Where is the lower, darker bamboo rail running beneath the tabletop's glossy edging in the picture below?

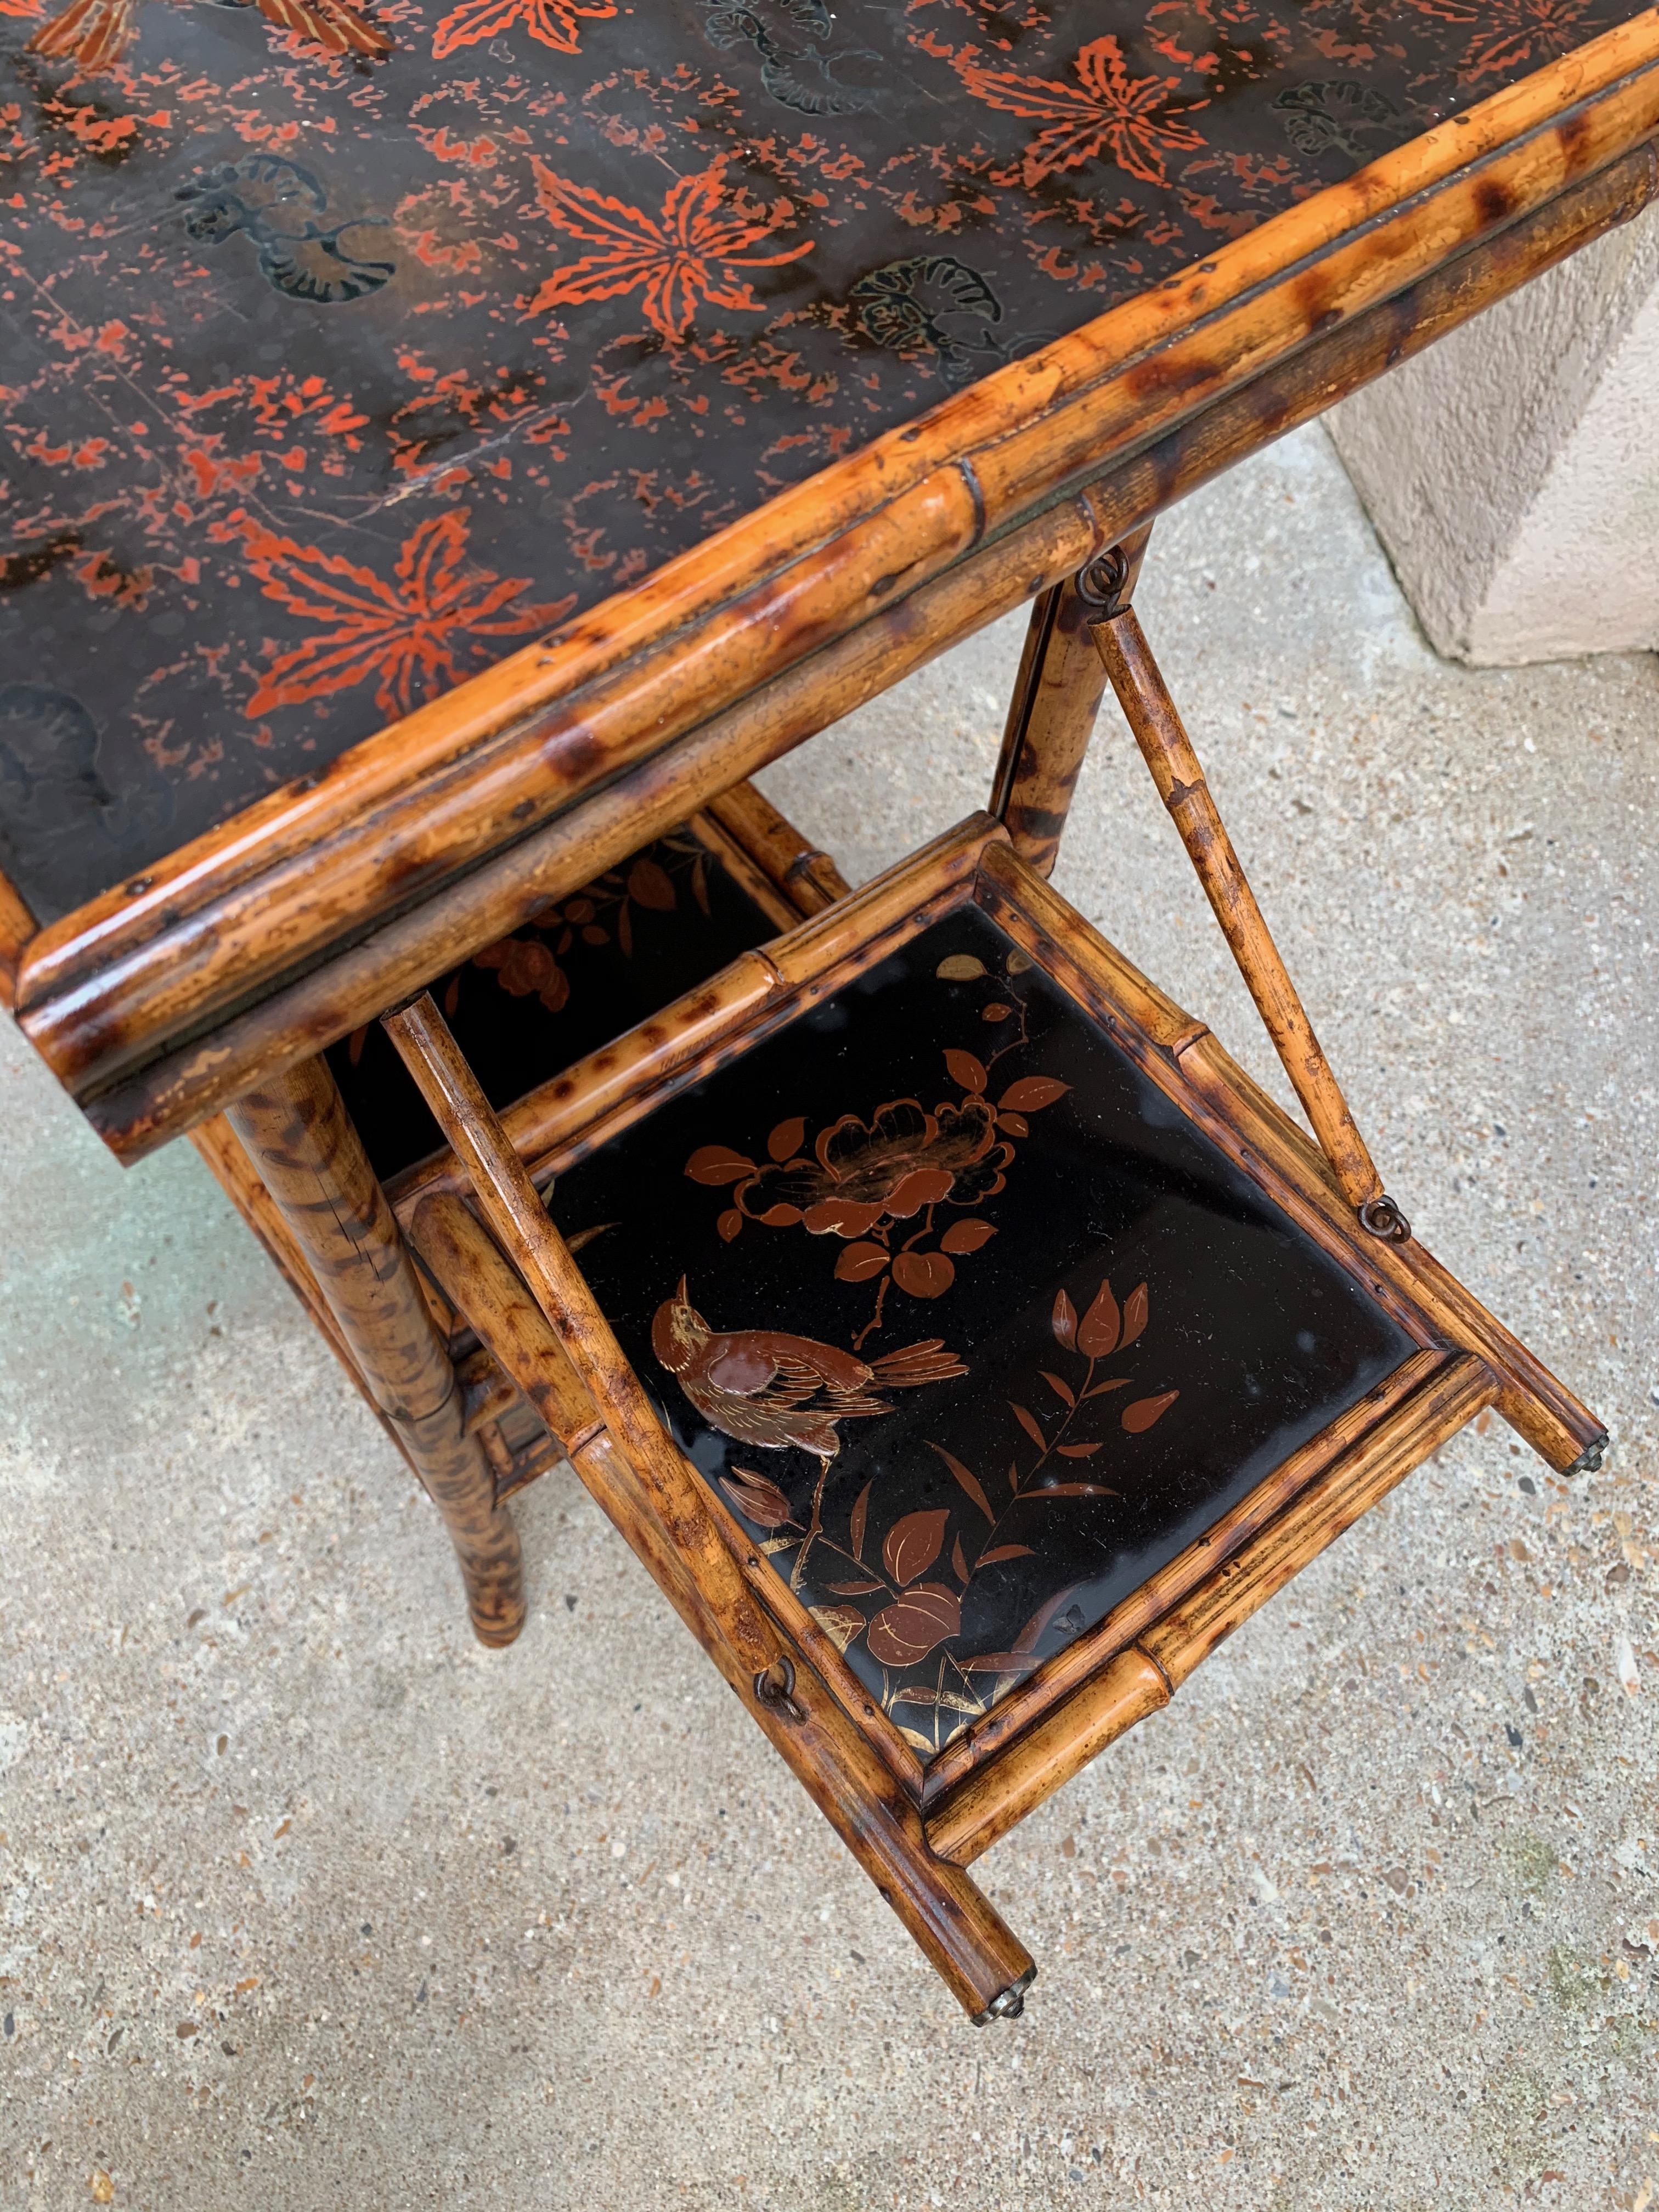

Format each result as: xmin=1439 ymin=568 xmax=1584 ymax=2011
xmin=65 ymin=129 xmax=1659 ymax=1159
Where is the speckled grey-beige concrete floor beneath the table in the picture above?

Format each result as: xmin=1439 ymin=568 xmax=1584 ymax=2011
xmin=0 ymin=431 xmax=1659 ymax=2212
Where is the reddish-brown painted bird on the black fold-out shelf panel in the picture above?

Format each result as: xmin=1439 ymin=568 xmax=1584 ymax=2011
xmin=650 ymin=1276 xmax=967 ymax=1464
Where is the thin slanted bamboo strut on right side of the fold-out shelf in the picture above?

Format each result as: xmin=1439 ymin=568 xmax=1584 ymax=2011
xmin=1091 ymin=597 xmax=1411 ymax=1243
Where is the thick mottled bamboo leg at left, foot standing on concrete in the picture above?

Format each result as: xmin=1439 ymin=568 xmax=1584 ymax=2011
xmin=228 ymin=1059 xmax=524 ymax=1646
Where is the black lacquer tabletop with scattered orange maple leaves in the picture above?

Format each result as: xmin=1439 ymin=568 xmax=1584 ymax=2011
xmin=0 ymin=0 xmax=1633 ymax=920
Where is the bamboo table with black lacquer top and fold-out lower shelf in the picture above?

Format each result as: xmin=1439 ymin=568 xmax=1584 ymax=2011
xmin=0 ymin=0 xmax=1659 ymax=2019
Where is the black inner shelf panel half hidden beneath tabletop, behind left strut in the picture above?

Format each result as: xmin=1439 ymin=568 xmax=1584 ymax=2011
xmin=336 ymin=830 xmax=778 ymax=1179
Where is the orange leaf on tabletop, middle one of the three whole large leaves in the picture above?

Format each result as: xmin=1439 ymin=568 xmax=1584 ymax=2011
xmin=529 ymin=157 xmax=812 ymax=338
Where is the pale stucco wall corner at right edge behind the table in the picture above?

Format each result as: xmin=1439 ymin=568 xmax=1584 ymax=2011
xmin=1327 ymin=208 xmax=1659 ymax=666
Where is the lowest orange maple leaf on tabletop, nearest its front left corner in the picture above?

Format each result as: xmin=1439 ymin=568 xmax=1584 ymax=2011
xmin=230 ymin=506 xmax=575 ymax=714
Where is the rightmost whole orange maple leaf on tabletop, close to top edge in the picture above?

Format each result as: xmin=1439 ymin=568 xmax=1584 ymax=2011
xmin=956 ymin=36 xmax=1207 ymax=186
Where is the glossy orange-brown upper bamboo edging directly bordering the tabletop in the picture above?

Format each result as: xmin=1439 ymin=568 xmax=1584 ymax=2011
xmin=20 ymin=30 xmax=1659 ymax=1141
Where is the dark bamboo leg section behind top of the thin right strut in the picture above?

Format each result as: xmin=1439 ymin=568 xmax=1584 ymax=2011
xmin=991 ymin=522 xmax=1153 ymax=876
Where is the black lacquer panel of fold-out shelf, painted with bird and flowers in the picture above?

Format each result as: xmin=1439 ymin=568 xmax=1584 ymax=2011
xmin=551 ymin=909 xmax=1415 ymax=1758
